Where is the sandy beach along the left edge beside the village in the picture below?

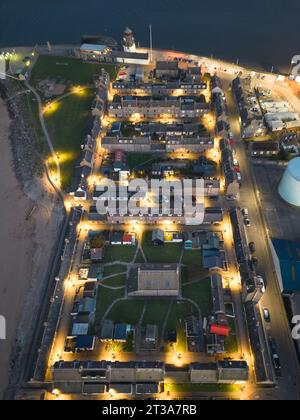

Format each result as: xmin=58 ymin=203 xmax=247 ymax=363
xmin=0 ymin=99 xmax=61 ymax=399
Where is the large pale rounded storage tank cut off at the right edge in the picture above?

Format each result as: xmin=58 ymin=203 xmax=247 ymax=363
xmin=278 ymin=157 xmax=300 ymax=207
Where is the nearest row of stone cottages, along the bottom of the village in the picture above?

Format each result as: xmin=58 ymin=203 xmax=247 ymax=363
xmin=52 ymin=360 xmax=249 ymax=393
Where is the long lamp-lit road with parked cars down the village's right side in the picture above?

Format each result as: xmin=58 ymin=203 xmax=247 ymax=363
xmin=221 ymin=74 xmax=300 ymax=400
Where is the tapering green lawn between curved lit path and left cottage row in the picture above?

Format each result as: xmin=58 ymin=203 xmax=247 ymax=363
xmin=45 ymin=91 xmax=94 ymax=189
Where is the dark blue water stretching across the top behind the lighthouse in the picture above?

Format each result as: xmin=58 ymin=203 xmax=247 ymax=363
xmin=0 ymin=0 xmax=300 ymax=69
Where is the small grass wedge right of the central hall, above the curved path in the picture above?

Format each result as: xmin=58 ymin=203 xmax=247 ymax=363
xmin=182 ymin=278 xmax=212 ymax=317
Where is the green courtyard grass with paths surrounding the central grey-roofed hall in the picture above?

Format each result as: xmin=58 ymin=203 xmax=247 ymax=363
xmin=96 ymin=236 xmax=212 ymax=352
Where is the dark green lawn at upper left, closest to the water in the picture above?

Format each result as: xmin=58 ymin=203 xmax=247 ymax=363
xmin=30 ymin=55 xmax=118 ymax=86
